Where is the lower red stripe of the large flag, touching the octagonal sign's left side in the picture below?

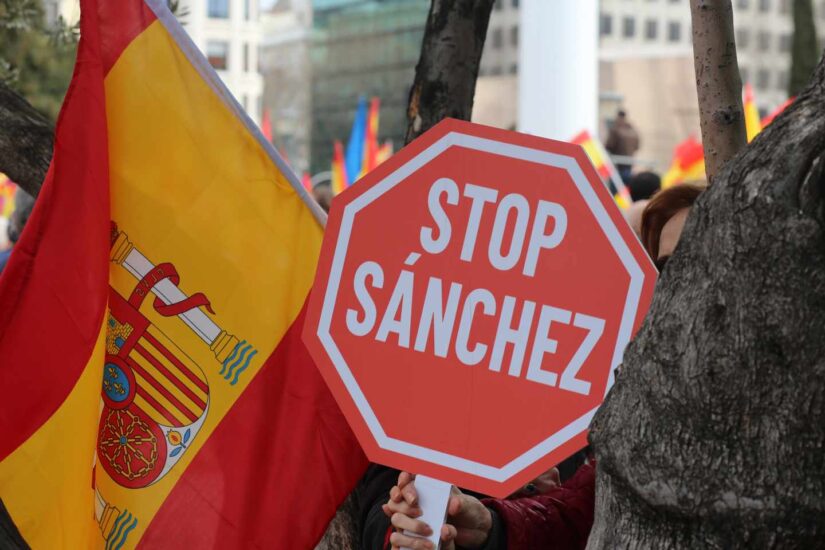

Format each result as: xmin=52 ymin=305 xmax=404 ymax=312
xmin=139 ymin=312 xmax=367 ymax=549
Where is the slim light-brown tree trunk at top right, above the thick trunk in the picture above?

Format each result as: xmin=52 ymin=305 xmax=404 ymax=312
xmin=690 ymin=0 xmax=747 ymax=182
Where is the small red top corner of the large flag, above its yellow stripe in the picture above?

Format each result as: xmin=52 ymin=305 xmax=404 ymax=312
xmin=96 ymin=0 xmax=157 ymax=73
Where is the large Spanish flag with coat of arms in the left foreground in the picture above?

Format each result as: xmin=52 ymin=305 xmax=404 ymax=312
xmin=0 ymin=0 xmax=366 ymax=550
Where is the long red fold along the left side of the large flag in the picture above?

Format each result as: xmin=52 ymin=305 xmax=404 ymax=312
xmin=0 ymin=2 xmax=109 ymax=460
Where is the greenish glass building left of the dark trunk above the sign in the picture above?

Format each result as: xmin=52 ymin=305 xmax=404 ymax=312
xmin=311 ymin=0 xmax=429 ymax=173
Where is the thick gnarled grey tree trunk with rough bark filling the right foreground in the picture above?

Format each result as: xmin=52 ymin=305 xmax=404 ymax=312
xmin=588 ymin=56 xmax=825 ymax=550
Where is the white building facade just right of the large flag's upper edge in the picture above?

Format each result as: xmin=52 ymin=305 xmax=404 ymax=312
xmin=179 ymin=0 xmax=263 ymax=123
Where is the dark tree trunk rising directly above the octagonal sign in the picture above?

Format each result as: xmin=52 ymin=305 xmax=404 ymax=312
xmin=406 ymin=0 xmax=494 ymax=143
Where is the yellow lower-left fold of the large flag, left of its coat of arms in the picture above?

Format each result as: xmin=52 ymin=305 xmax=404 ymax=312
xmin=0 ymin=316 xmax=106 ymax=549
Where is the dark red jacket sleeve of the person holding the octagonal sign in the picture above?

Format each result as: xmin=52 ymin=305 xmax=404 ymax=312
xmin=482 ymin=464 xmax=596 ymax=550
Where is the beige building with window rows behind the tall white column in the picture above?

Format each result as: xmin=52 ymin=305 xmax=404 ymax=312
xmin=473 ymin=0 xmax=825 ymax=170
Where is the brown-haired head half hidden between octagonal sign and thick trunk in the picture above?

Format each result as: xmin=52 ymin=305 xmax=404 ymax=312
xmin=642 ymin=183 xmax=705 ymax=271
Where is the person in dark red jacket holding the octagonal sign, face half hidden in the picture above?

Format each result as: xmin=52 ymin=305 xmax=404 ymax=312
xmin=373 ymin=184 xmax=704 ymax=550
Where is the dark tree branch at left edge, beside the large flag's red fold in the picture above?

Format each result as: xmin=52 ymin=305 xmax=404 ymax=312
xmin=0 ymin=82 xmax=54 ymax=197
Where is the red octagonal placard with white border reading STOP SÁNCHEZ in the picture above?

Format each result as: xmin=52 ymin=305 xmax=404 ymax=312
xmin=304 ymin=120 xmax=656 ymax=497
